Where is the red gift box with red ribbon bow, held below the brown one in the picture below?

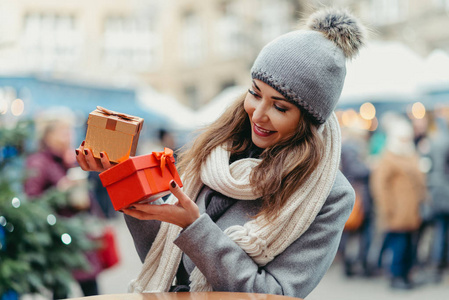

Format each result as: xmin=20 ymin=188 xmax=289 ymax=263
xmin=100 ymin=148 xmax=182 ymax=210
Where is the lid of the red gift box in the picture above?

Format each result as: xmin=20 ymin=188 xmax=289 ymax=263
xmin=99 ymin=154 xmax=175 ymax=187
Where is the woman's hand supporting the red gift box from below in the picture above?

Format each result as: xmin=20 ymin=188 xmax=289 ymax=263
xmin=123 ymin=180 xmax=200 ymax=228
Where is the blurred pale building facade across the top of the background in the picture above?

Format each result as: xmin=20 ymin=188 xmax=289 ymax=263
xmin=0 ymin=0 xmax=449 ymax=109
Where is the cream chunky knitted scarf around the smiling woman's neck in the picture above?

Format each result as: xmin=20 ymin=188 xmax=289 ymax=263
xmin=129 ymin=114 xmax=341 ymax=293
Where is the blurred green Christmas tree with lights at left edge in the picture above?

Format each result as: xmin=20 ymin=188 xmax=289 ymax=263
xmin=0 ymin=122 xmax=95 ymax=300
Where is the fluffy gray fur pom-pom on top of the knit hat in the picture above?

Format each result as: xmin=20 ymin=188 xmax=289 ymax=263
xmin=307 ymin=9 xmax=365 ymax=58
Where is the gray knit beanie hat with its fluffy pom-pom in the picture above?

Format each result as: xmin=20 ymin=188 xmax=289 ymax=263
xmin=251 ymin=9 xmax=365 ymax=124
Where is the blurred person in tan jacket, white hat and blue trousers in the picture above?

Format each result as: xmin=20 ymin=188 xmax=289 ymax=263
xmin=370 ymin=116 xmax=426 ymax=289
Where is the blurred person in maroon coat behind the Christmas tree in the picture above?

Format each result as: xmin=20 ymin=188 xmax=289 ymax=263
xmin=24 ymin=109 xmax=102 ymax=299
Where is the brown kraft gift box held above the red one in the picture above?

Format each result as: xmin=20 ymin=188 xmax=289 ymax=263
xmin=84 ymin=106 xmax=143 ymax=163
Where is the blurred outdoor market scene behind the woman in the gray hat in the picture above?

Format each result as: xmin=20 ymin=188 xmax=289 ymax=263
xmin=0 ymin=0 xmax=449 ymax=300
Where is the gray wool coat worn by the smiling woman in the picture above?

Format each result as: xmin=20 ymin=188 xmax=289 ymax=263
xmin=125 ymin=171 xmax=355 ymax=298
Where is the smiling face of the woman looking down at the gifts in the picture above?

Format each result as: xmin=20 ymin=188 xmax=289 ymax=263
xmin=244 ymin=79 xmax=301 ymax=148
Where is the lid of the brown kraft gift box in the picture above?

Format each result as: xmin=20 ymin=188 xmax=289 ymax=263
xmin=87 ymin=106 xmax=143 ymax=135
